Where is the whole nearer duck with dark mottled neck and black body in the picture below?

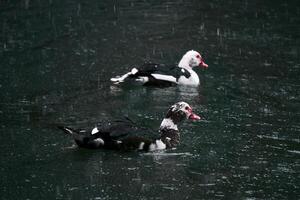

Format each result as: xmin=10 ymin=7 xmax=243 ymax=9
xmin=58 ymin=102 xmax=200 ymax=151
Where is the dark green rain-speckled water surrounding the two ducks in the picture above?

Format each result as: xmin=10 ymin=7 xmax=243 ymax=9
xmin=0 ymin=0 xmax=300 ymax=199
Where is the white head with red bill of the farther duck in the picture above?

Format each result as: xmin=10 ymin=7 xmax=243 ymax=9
xmin=178 ymin=50 xmax=208 ymax=68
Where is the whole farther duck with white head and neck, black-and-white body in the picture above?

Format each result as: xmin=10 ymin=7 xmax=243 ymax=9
xmin=110 ymin=50 xmax=208 ymax=86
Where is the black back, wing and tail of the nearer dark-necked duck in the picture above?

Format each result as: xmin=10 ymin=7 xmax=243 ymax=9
xmin=58 ymin=119 xmax=159 ymax=150
